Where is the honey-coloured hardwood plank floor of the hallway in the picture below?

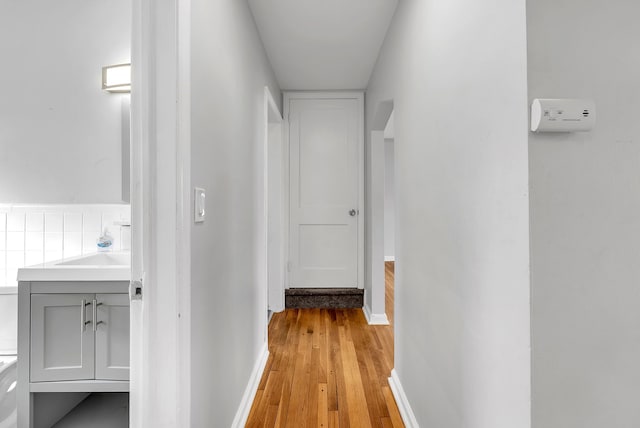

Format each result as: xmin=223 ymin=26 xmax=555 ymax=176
xmin=246 ymin=262 xmax=404 ymax=428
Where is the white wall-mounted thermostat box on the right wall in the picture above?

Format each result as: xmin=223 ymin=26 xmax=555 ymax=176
xmin=531 ymin=98 xmax=596 ymax=132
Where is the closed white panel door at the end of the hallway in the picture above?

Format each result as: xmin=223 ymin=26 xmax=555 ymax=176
xmin=288 ymin=97 xmax=362 ymax=288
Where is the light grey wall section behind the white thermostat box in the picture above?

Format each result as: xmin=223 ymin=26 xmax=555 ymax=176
xmin=527 ymin=0 xmax=640 ymax=428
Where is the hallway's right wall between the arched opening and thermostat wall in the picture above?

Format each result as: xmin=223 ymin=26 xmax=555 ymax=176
xmin=366 ymin=0 xmax=530 ymax=428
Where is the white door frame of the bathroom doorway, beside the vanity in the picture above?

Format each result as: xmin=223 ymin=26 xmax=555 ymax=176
xmin=130 ymin=0 xmax=191 ymax=428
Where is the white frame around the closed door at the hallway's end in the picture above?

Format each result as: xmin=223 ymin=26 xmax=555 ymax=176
xmin=282 ymin=91 xmax=366 ymax=289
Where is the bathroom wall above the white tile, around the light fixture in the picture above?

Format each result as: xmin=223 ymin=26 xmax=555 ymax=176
xmin=0 ymin=0 xmax=131 ymax=203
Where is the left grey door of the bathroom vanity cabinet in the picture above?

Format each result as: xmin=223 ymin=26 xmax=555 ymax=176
xmin=31 ymin=294 xmax=94 ymax=382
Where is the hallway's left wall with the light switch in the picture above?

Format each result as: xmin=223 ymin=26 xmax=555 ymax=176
xmin=191 ymin=0 xmax=281 ymax=427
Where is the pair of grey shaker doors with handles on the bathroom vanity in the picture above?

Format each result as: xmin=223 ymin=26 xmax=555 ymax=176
xmin=30 ymin=293 xmax=129 ymax=382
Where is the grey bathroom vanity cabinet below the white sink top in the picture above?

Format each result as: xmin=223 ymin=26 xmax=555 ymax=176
xmin=18 ymin=281 xmax=129 ymax=428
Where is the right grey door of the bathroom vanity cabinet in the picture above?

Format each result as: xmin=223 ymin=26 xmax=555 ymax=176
xmin=96 ymin=294 xmax=129 ymax=380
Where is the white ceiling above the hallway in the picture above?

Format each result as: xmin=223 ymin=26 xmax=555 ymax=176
xmin=248 ymin=0 xmax=398 ymax=90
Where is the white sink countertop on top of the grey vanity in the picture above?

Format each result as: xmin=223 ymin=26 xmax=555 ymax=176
xmin=18 ymin=252 xmax=131 ymax=282
